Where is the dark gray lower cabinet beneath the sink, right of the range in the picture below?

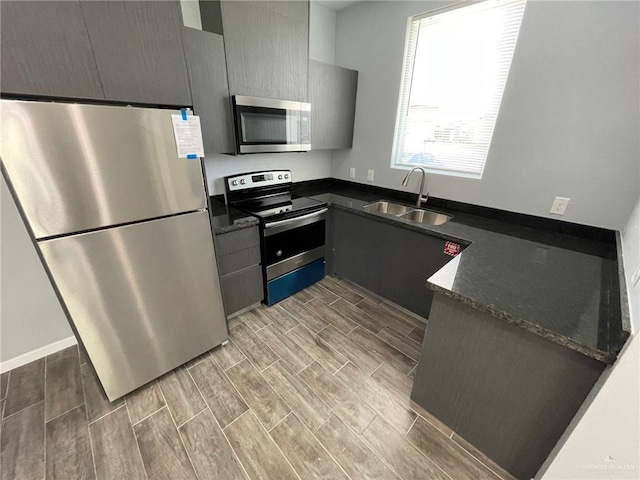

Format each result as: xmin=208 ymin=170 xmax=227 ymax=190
xmin=328 ymin=208 xmax=451 ymax=318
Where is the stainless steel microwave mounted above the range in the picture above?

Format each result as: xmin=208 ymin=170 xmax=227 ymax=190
xmin=231 ymin=95 xmax=311 ymax=153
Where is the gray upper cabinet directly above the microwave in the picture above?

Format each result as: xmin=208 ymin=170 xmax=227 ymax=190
xmin=222 ymin=0 xmax=309 ymax=102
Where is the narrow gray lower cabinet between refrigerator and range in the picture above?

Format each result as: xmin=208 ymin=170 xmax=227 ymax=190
xmin=215 ymin=227 xmax=264 ymax=317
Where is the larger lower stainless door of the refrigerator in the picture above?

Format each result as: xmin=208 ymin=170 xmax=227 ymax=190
xmin=39 ymin=212 xmax=228 ymax=400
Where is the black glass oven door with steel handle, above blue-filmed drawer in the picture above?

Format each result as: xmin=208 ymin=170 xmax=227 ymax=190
xmin=263 ymin=208 xmax=327 ymax=281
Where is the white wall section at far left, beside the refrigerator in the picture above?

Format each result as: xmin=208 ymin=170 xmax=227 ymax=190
xmin=0 ymin=178 xmax=75 ymax=370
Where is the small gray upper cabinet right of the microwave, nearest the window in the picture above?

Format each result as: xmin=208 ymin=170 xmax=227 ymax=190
xmin=309 ymin=60 xmax=358 ymax=150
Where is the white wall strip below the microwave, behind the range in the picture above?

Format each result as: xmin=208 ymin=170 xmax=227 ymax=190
xmin=204 ymin=150 xmax=331 ymax=195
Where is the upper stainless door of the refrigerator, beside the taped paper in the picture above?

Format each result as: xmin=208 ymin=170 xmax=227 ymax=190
xmin=0 ymin=100 xmax=206 ymax=238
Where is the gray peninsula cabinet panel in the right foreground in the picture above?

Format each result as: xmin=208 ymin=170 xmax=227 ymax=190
xmin=411 ymin=294 xmax=604 ymax=479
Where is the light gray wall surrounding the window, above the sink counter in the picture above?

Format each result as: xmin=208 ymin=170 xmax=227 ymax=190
xmin=332 ymin=0 xmax=640 ymax=229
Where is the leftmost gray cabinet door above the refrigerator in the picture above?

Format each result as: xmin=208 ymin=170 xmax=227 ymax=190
xmin=0 ymin=1 xmax=104 ymax=98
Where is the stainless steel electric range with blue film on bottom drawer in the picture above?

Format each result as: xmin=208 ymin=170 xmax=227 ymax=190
xmin=224 ymin=170 xmax=327 ymax=305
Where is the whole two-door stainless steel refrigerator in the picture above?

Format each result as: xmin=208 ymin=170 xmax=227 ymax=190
xmin=0 ymin=100 xmax=228 ymax=400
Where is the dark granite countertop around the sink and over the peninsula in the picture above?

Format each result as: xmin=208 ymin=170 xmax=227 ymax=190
xmin=298 ymin=184 xmax=629 ymax=363
